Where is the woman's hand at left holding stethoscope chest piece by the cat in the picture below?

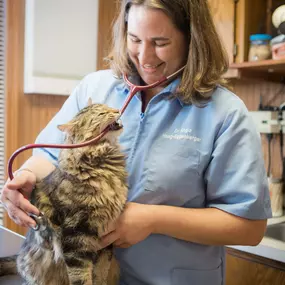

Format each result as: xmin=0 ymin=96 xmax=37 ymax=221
xmin=0 ymin=169 xmax=39 ymax=227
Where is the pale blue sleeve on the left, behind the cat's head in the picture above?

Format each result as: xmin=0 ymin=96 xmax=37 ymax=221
xmin=33 ymin=76 xmax=88 ymax=165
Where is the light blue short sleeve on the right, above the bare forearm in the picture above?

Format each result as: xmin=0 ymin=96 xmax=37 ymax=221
xmin=205 ymin=107 xmax=271 ymax=219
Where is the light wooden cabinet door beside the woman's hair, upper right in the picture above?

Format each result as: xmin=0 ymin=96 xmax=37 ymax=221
xmin=208 ymin=0 xmax=234 ymax=63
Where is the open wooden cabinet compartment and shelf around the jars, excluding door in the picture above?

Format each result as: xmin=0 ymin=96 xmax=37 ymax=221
xmin=231 ymin=0 xmax=285 ymax=79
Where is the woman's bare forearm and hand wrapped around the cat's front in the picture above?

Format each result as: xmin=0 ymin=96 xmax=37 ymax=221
xmin=101 ymin=203 xmax=266 ymax=247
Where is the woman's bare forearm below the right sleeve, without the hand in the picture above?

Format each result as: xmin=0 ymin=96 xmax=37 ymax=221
xmin=150 ymin=202 xmax=267 ymax=245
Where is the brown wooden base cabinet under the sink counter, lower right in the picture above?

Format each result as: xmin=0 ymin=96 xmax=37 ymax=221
xmin=226 ymin=249 xmax=285 ymax=285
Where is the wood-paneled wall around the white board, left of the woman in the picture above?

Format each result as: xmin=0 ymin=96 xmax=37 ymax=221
xmin=4 ymin=0 xmax=116 ymax=233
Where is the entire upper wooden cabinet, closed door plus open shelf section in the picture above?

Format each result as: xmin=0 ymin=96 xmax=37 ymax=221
xmin=208 ymin=0 xmax=285 ymax=82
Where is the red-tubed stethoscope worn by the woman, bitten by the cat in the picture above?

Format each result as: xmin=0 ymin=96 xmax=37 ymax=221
xmin=8 ymin=66 xmax=185 ymax=180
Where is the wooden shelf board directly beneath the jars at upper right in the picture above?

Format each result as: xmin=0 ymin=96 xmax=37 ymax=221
xmin=225 ymin=59 xmax=285 ymax=82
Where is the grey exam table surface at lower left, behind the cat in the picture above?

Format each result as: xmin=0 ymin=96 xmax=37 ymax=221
xmin=0 ymin=226 xmax=25 ymax=285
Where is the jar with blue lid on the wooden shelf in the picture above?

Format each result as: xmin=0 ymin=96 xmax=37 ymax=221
xmin=248 ymin=34 xmax=272 ymax=61
